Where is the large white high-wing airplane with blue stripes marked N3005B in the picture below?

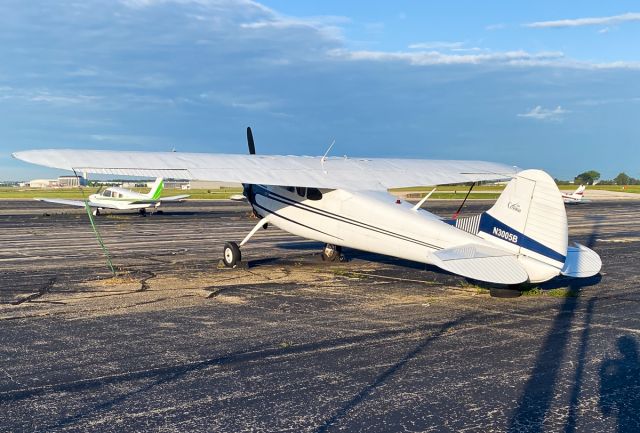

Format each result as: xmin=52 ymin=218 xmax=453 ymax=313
xmin=13 ymin=128 xmax=602 ymax=285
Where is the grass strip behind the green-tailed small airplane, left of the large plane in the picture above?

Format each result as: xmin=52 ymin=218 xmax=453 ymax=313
xmin=0 ymin=187 xmax=242 ymax=200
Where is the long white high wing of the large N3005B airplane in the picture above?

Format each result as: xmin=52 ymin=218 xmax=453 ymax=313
xmin=13 ymin=149 xmax=517 ymax=190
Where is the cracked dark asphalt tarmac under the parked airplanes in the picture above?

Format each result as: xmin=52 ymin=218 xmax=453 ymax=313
xmin=0 ymin=201 xmax=640 ymax=432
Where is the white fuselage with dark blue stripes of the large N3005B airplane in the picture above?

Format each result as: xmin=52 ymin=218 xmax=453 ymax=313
xmin=251 ymin=185 xmax=490 ymax=263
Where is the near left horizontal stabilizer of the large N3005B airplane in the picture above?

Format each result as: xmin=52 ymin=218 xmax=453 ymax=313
xmin=432 ymin=244 xmax=529 ymax=284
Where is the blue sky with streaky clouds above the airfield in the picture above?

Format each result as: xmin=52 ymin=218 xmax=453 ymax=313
xmin=0 ymin=0 xmax=640 ymax=180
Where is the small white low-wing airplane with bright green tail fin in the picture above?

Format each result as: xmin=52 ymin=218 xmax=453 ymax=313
xmin=35 ymin=177 xmax=189 ymax=215
